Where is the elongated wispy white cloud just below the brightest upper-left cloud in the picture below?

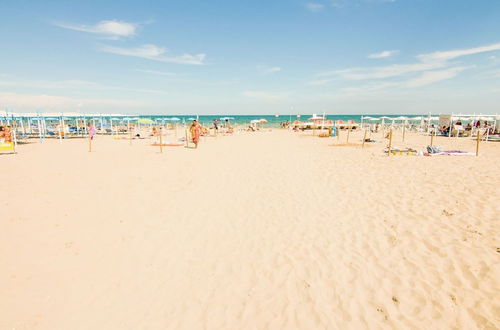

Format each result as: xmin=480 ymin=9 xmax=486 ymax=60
xmin=101 ymin=44 xmax=206 ymax=65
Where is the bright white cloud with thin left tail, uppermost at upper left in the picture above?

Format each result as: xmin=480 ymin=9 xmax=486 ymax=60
xmin=54 ymin=20 xmax=138 ymax=39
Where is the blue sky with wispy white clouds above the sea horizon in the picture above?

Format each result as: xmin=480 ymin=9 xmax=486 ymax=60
xmin=0 ymin=0 xmax=500 ymax=115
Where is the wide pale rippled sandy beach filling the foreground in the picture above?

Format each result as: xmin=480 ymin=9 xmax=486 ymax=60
xmin=0 ymin=130 xmax=500 ymax=330
